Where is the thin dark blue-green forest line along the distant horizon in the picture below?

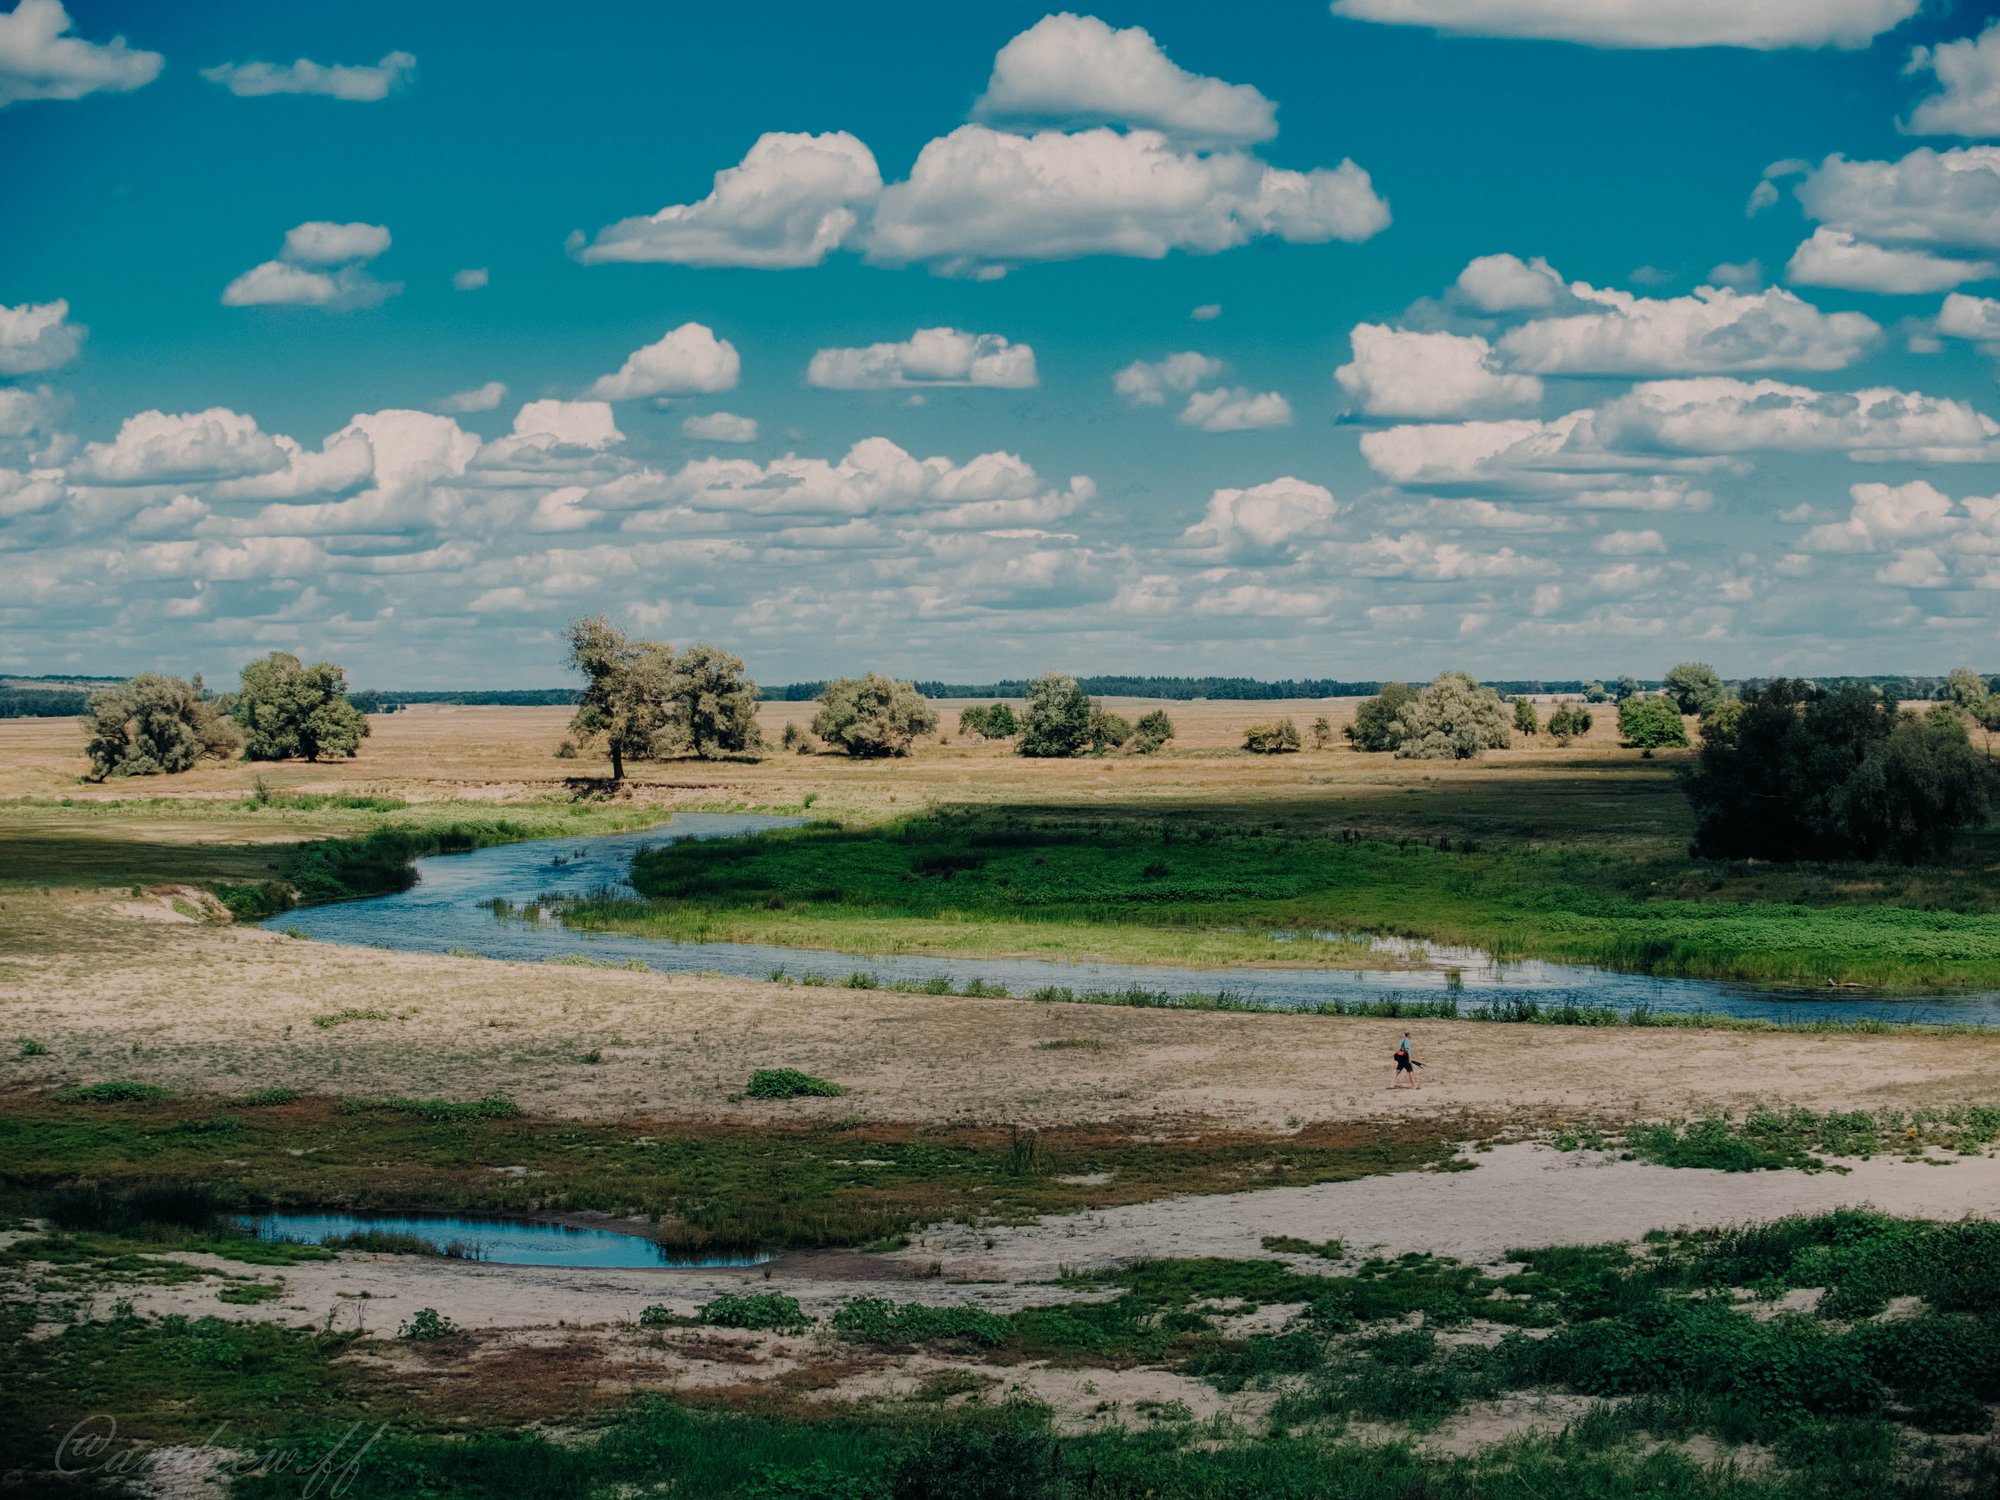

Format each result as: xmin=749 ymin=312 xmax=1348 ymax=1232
xmin=0 ymin=676 xmax=2000 ymax=718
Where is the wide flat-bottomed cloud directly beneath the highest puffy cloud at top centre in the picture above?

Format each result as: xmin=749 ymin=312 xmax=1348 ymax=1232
xmin=868 ymin=124 xmax=1388 ymax=276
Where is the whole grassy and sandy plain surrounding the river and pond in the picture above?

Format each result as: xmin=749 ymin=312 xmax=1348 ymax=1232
xmin=0 ymin=700 xmax=2000 ymax=1498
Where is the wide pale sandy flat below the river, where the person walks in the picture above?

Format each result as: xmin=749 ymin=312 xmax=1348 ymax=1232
xmin=0 ymin=892 xmax=2000 ymax=1130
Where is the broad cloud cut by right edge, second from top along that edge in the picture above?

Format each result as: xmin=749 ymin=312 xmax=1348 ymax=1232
xmin=1798 ymin=146 xmax=2000 ymax=250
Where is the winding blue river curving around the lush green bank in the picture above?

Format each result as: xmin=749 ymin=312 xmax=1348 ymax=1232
xmin=264 ymin=812 xmax=2000 ymax=1026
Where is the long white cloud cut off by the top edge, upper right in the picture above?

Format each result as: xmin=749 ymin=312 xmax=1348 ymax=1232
xmin=1332 ymin=0 xmax=1920 ymax=52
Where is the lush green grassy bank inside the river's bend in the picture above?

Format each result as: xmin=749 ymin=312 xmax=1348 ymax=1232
xmin=566 ymin=808 xmax=2000 ymax=988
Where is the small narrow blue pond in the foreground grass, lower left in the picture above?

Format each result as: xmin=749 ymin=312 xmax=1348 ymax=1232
xmin=242 ymin=1214 xmax=770 ymax=1270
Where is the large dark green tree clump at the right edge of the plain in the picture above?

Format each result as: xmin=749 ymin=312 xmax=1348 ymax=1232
xmin=1686 ymin=678 xmax=1990 ymax=862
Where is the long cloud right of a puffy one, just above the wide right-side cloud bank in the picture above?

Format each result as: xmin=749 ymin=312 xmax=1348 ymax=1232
xmin=1496 ymin=284 xmax=1882 ymax=374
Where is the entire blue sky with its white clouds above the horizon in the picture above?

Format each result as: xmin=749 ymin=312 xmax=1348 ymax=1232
xmin=0 ymin=0 xmax=2000 ymax=686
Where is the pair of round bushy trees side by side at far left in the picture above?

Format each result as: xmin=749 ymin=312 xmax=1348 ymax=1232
xmin=82 ymin=652 xmax=368 ymax=782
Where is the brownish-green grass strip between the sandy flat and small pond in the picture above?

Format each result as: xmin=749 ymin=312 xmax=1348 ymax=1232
xmin=0 ymin=1086 xmax=1480 ymax=1254
